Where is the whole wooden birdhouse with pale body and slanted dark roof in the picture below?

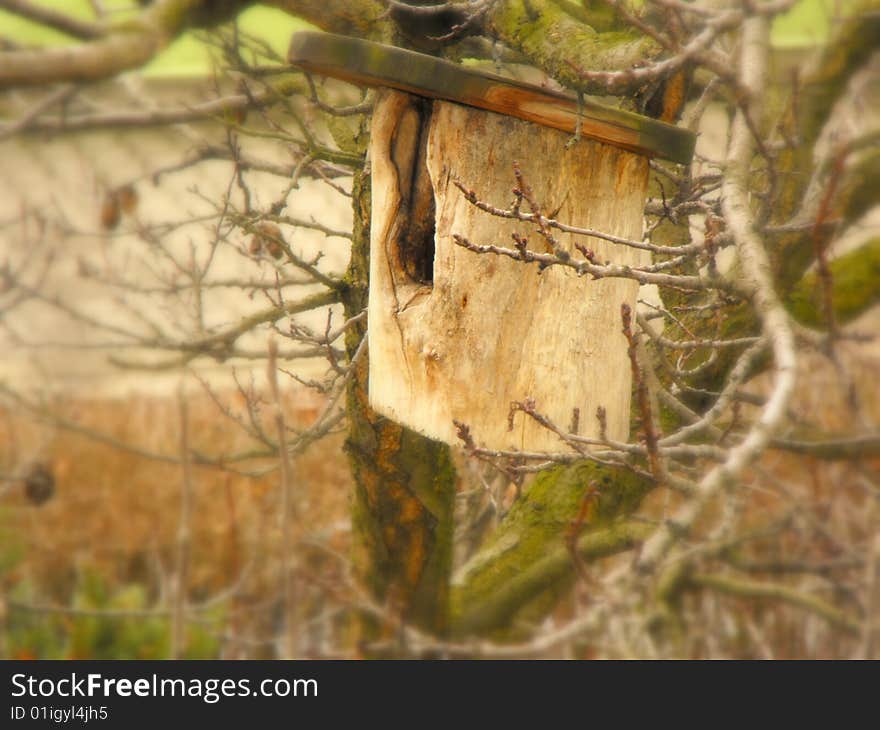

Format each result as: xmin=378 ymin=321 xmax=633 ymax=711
xmin=290 ymin=33 xmax=694 ymax=452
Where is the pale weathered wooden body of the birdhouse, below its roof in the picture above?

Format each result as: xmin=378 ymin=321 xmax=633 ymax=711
xmin=369 ymin=92 xmax=648 ymax=451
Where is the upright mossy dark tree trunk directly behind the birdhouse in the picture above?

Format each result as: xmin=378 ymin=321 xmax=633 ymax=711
xmin=344 ymin=166 xmax=456 ymax=640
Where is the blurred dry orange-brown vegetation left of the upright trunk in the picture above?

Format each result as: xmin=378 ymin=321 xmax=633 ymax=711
xmin=0 ymin=392 xmax=350 ymax=658
